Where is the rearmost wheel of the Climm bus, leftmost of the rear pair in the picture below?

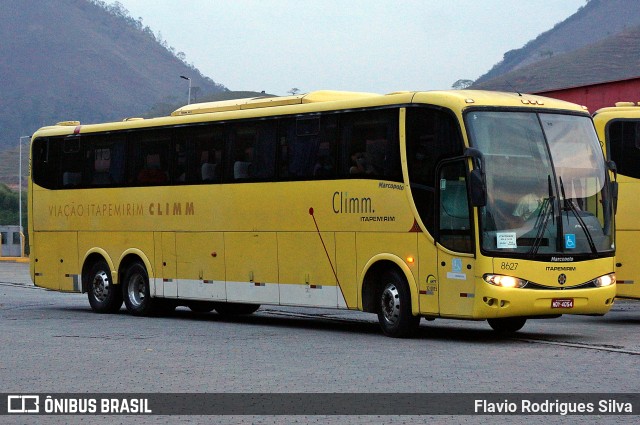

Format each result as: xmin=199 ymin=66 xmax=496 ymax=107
xmin=87 ymin=260 xmax=122 ymax=313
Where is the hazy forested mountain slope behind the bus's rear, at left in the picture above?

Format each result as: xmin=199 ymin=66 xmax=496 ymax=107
xmin=0 ymin=0 xmax=228 ymax=150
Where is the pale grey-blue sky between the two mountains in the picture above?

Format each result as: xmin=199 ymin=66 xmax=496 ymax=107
xmin=114 ymin=0 xmax=586 ymax=95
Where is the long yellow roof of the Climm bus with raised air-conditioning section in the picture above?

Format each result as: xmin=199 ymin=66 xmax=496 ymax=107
xmin=34 ymin=90 xmax=587 ymax=136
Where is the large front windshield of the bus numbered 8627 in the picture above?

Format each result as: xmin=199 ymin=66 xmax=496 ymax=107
xmin=467 ymin=111 xmax=614 ymax=258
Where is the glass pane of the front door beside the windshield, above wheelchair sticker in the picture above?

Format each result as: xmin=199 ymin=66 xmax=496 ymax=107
xmin=438 ymin=160 xmax=473 ymax=252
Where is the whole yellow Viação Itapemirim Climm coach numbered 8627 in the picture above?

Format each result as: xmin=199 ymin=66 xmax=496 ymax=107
xmin=29 ymin=91 xmax=616 ymax=337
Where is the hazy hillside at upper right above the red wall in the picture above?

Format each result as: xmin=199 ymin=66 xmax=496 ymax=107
xmin=470 ymin=0 xmax=640 ymax=92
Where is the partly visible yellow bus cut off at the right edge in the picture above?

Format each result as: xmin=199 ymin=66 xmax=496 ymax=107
xmin=593 ymin=102 xmax=640 ymax=299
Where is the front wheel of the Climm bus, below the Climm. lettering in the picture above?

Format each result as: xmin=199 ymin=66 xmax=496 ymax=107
xmin=378 ymin=270 xmax=420 ymax=338
